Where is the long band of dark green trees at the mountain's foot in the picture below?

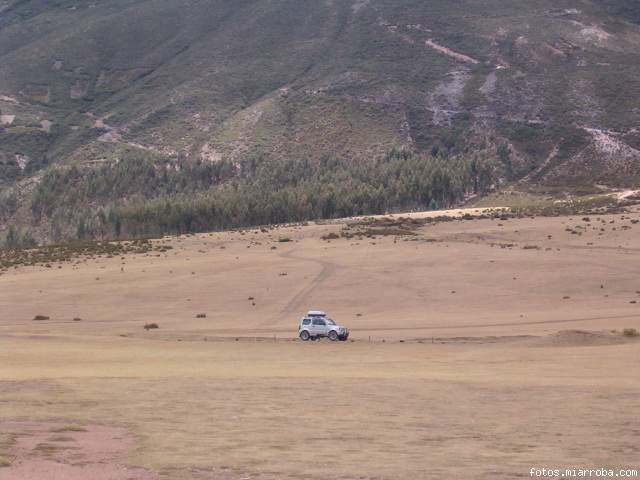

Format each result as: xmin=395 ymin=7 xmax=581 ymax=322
xmin=3 ymin=149 xmax=502 ymax=244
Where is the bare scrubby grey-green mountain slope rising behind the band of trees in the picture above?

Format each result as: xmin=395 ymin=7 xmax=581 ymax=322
xmin=0 ymin=0 xmax=640 ymax=238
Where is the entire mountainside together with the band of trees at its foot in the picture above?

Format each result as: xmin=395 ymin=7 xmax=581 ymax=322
xmin=0 ymin=0 xmax=640 ymax=242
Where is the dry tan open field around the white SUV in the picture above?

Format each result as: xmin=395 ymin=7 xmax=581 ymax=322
xmin=0 ymin=207 xmax=640 ymax=480
